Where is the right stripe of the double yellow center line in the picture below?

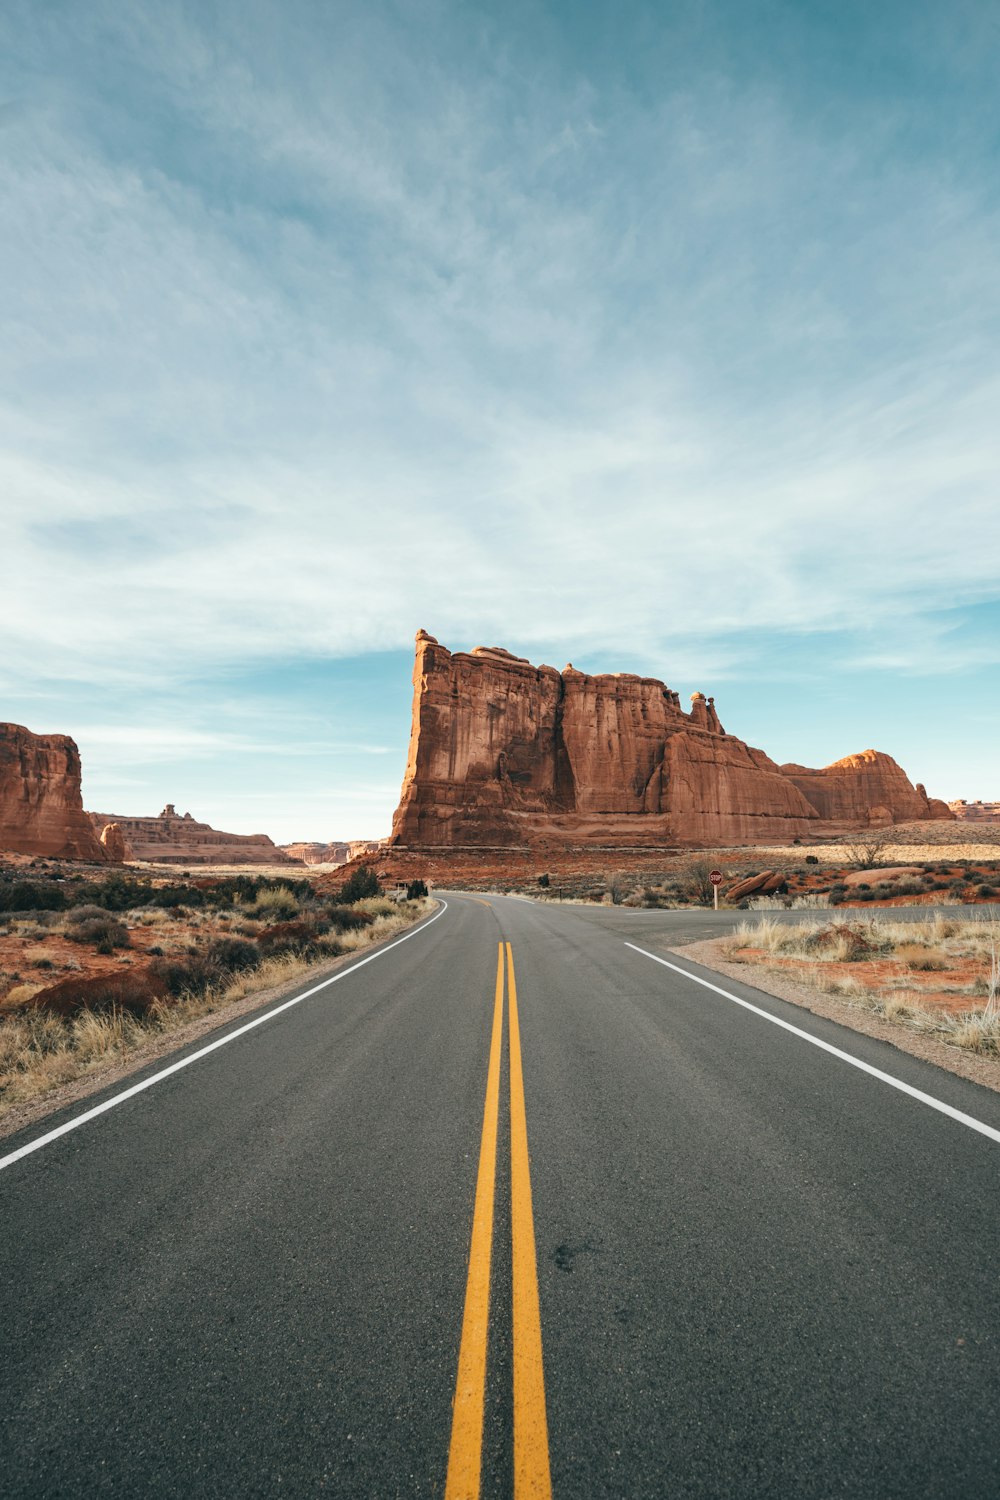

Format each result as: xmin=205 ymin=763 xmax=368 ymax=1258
xmin=507 ymin=944 xmax=552 ymax=1500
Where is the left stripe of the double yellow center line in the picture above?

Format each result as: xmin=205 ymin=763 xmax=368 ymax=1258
xmin=444 ymin=944 xmax=504 ymax=1500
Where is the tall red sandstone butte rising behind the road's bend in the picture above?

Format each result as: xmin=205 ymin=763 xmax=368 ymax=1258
xmin=391 ymin=630 xmax=954 ymax=848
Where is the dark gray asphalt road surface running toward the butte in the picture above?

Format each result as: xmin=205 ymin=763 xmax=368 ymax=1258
xmin=0 ymin=896 xmax=1000 ymax=1500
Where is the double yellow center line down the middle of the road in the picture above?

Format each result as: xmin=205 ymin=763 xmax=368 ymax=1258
xmin=445 ymin=942 xmax=552 ymax=1500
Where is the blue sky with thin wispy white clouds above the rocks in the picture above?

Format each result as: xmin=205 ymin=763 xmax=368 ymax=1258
xmin=0 ymin=0 xmax=1000 ymax=840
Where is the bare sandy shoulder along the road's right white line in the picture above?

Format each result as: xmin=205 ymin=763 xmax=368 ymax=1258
xmin=669 ymin=938 xmax=1000 ymax=1094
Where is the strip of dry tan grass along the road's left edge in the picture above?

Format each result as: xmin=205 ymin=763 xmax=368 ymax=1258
xmin=0 ymin=897 xmax=432 ymax=1118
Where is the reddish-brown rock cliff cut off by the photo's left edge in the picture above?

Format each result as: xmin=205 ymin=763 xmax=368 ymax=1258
xmin=0 ymin=725 xmax=108 ymax=864
